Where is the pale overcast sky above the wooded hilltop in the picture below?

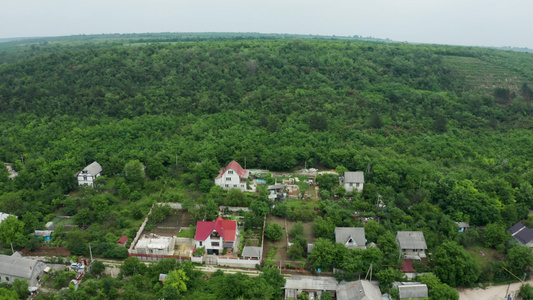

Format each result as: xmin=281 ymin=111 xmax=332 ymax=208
xmin=0 ymin=0 xmax=533 ymax=49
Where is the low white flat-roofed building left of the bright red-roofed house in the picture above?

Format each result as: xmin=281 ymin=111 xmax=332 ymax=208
xmin=130 ymin=233 xmax=176 ymax=259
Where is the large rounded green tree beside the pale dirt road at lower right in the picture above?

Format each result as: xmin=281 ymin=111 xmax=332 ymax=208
xmin=433 ymin=242 xmax=481 ymax=286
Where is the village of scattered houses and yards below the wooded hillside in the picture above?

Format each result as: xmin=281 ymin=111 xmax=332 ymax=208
xmin=0 ymin=161 xmax=533 ymax=300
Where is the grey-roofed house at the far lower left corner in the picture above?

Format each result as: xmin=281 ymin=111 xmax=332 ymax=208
xmin=0 ymin=252 xmax=46 ymax=290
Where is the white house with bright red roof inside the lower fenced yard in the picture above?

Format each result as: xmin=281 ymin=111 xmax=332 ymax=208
xmin=194 ymin=216 xmax=238 ymax=255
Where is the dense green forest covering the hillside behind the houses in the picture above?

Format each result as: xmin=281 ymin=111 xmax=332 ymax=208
xmin=0 ymin=36 xmax=533 ymax=299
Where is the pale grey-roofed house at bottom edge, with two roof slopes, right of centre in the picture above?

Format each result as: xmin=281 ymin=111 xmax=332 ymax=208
xmin=336 ymin=280 xmax=383 ymax=300
